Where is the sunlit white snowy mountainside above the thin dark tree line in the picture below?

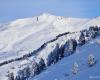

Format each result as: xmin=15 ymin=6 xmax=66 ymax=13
xmin=0 ymin=13 xmax=100 ymax=61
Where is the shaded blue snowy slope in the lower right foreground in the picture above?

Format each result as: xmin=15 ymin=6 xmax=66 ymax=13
xmin=29 ymin=37 xmax=100 ymax=80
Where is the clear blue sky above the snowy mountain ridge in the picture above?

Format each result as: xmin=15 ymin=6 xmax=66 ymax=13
xmin=0 ymin=0 xmax=100 ymax=23
